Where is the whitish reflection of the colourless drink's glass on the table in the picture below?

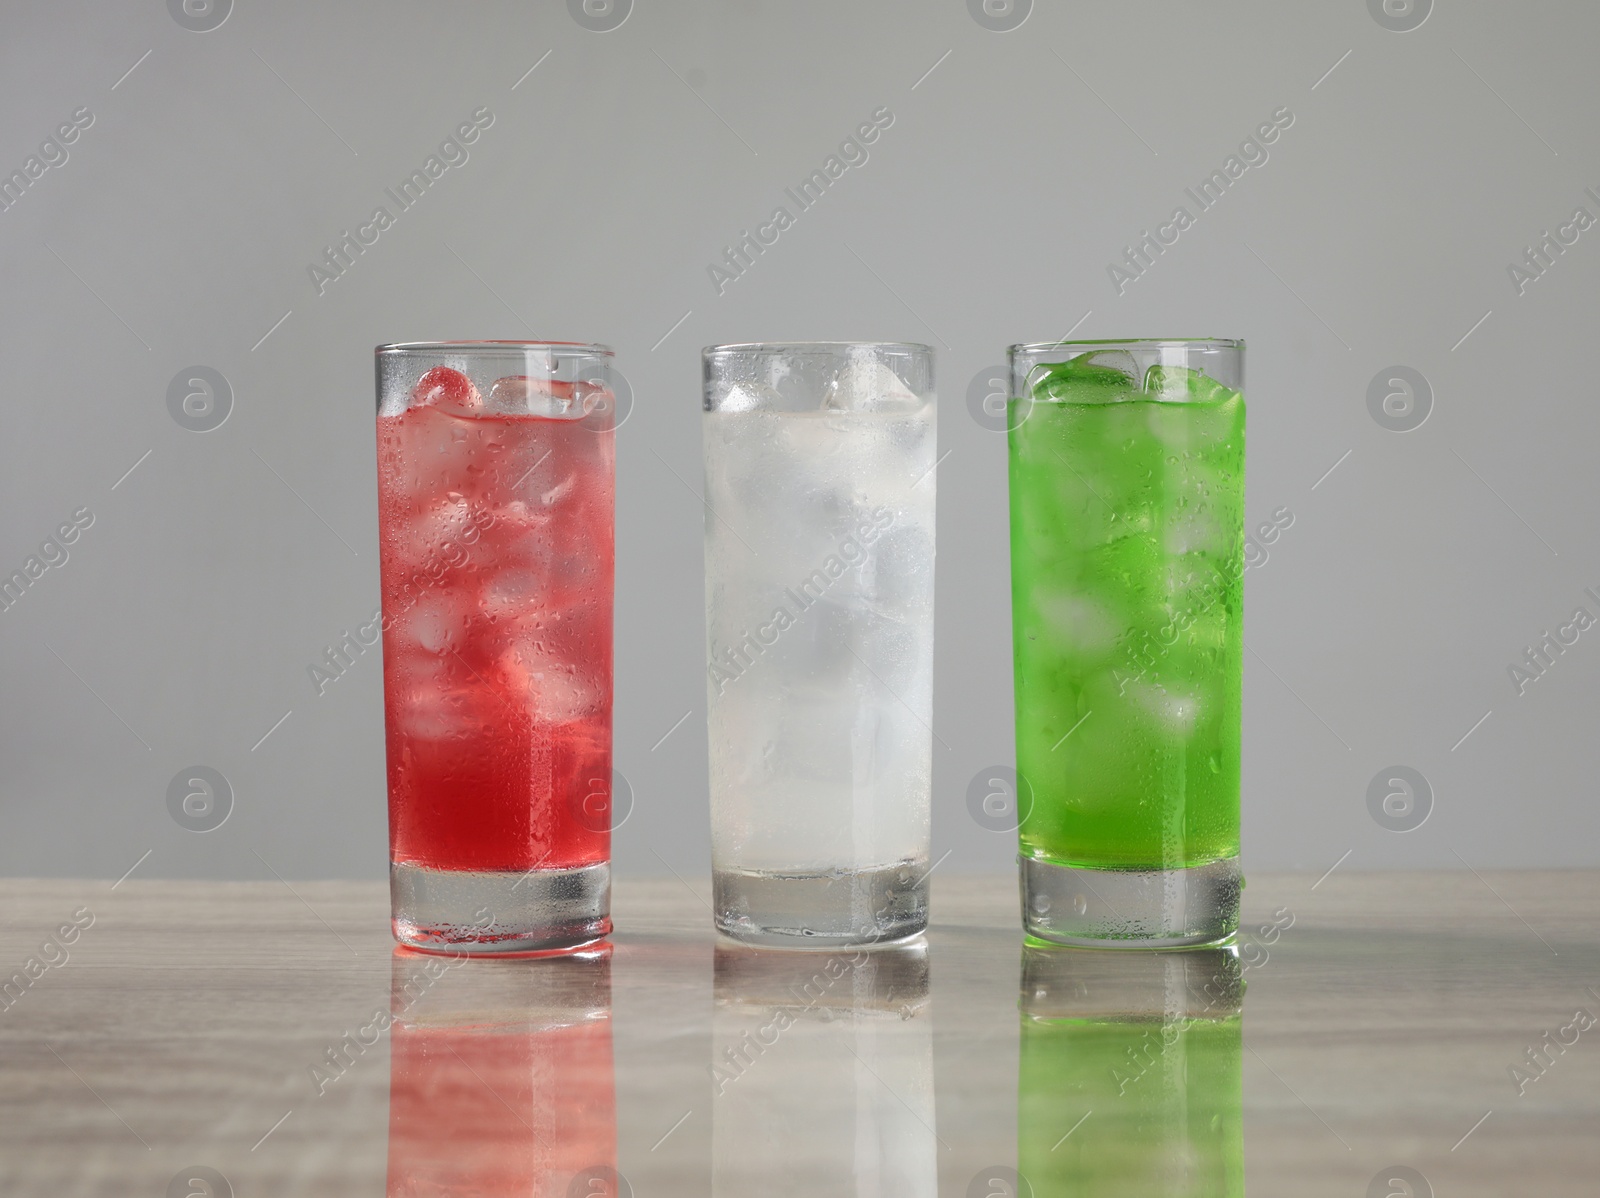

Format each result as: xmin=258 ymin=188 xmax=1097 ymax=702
xmin=710 ymin=940 xmax=938 ymax=1198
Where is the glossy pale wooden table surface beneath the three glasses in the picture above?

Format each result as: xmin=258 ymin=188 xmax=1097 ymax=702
xmin=0 ymin=872 xmax=1600 ymax=1198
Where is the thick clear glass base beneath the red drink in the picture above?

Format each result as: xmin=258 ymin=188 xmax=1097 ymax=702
xmin=389 ymin=861 xmax=611 ymax=955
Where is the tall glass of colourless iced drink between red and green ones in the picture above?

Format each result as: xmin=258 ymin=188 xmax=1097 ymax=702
xmin=704 ymin=342 xmax=936 ymax=947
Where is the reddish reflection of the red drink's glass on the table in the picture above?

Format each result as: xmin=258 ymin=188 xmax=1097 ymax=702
xmin=389 ymin=944 xmax=618 ymax=1198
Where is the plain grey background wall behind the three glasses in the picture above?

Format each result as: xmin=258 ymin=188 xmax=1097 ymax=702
xmin=0 ymin=0 xmax=1600 ymax=878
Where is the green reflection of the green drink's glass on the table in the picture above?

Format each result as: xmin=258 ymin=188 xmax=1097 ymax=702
xmin=1018 ymin=944 xmax=1245 ymax=1198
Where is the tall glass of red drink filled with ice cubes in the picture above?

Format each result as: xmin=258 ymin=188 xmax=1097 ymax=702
xmin=378 ymin=341 xmax=618 ymax=953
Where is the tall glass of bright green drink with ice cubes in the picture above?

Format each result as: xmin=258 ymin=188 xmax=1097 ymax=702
xmin=1008 ymin=341 xmax=1245 ymax=947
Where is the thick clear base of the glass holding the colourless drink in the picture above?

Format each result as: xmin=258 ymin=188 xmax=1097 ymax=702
xmin=712 ymin=859 xmax=928 ymax=948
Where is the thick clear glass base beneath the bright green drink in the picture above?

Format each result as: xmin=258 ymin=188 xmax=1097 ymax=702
xmin=1018 ymin=856 xmax=1245 ymax=948
